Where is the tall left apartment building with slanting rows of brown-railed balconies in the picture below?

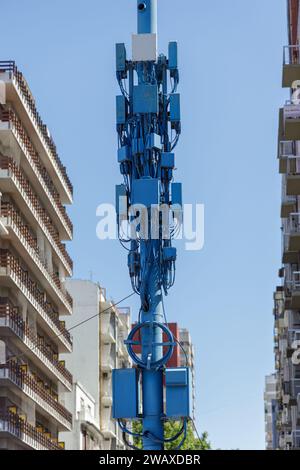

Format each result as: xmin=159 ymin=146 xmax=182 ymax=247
xmin=0 ymin=62 xmax=73 ymax=450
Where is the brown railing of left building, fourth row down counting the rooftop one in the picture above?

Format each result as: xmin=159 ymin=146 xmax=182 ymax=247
xmin=1 ymin=202 xmax=72 ymax=308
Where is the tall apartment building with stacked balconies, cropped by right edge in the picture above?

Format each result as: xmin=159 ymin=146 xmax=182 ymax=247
xmin=273 ymin=0 xmax=300 ymax=449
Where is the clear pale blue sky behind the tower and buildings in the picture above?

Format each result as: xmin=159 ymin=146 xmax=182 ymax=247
xmin=0 ymin=0 xmax=287 ymax=449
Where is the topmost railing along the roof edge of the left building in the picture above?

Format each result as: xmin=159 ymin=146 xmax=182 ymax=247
xmin=0 ymin=61 xmax=73 ymax=195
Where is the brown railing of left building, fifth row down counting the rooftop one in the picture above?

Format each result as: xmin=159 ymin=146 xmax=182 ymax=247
xmin=0 ymin=250 xmax=72 ymax=345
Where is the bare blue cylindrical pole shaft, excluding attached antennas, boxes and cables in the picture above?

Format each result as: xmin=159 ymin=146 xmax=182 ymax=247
xmin=137 ymin=0 xmax=164 ymax=450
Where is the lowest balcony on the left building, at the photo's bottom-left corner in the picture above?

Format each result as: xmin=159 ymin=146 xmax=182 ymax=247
xmin=0 ymin=413 xmax=62 ymax=450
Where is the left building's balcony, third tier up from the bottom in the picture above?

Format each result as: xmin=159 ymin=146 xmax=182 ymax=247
xmin=0 ymin=298 xmax=73 ymax=391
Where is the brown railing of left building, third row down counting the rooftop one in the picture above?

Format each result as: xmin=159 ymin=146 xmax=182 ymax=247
xmin=0 ymin=156 xmax=73 ymax=269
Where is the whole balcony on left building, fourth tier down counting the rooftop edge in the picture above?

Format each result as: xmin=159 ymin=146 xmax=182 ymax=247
xmin=1 ymin=202 xmax=72 ymax=313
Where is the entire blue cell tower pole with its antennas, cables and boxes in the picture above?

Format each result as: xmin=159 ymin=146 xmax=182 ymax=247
xmin=113 ymin=0 xmax=184 ymax=450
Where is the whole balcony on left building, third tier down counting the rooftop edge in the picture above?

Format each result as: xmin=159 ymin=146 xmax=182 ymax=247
xmin=0 ymin=156 xmax=72 ymax=270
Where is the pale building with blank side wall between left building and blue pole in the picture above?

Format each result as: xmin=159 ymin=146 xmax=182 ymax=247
xmin=61 ymin=279 xmax=132 ymax=450
